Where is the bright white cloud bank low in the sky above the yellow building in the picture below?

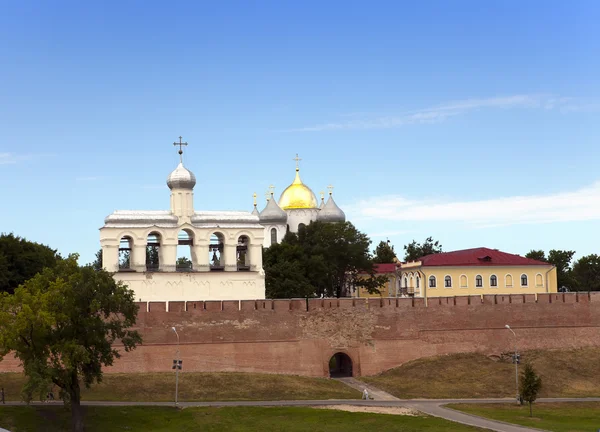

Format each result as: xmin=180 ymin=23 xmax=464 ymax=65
xmin=348 ymin=181 xmax=600 ymax=228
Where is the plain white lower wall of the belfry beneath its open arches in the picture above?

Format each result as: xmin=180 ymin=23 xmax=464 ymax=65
xmin=114 ymin=271 xmax=265 ymax=302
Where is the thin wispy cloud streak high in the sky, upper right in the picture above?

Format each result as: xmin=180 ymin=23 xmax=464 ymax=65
xmin=292 ymin=95 xmax=597 ymax=132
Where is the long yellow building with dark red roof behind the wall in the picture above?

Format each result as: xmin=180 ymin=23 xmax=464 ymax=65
xmin=398 ymin=248 xmax=557 ymax=298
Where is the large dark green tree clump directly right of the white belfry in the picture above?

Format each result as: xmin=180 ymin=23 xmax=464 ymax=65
xmin=263 ymin=222 xmax=387 ymax=298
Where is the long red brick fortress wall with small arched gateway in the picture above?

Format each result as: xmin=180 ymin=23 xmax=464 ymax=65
xmin=0 ymin=292 xmax=600 ymax=376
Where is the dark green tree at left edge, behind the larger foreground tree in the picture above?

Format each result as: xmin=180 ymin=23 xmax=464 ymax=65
xmin=0 ymin=233 xmax=60 ymax=293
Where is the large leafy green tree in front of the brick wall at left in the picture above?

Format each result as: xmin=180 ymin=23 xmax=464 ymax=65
xmin=0 ymin=255 xmax=141 ymax=432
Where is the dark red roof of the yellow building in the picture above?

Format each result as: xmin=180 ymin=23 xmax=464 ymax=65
xmin=420 ymin=247 xmax=551 ymax=267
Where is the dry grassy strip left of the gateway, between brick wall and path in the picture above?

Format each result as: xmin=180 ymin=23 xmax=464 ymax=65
xmin=0 ymin=372 xmax=361 ymax=402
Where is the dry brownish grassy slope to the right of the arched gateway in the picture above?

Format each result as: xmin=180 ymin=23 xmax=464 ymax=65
xmin=361 ymin=347 xmax=600 ymax=398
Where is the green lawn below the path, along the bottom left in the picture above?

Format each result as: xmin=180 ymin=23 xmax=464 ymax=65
xmin=0 ymin=406 xmax=488 ymax=432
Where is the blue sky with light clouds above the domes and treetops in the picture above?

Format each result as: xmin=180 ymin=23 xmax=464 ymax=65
xmin=0 ymin=0 xmax=600 ymax=262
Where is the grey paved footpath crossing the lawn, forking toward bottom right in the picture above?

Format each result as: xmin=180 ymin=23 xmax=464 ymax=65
xmin=0 ymin=398 xmax=600 ymax=432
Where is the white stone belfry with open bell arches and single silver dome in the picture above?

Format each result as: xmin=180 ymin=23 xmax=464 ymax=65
xmin=100 ymin=157 xmax=265 ymax=301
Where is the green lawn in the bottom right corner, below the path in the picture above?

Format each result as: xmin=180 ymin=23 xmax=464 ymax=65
xmin=448 ymin=402 xmax=600 ymax=432
